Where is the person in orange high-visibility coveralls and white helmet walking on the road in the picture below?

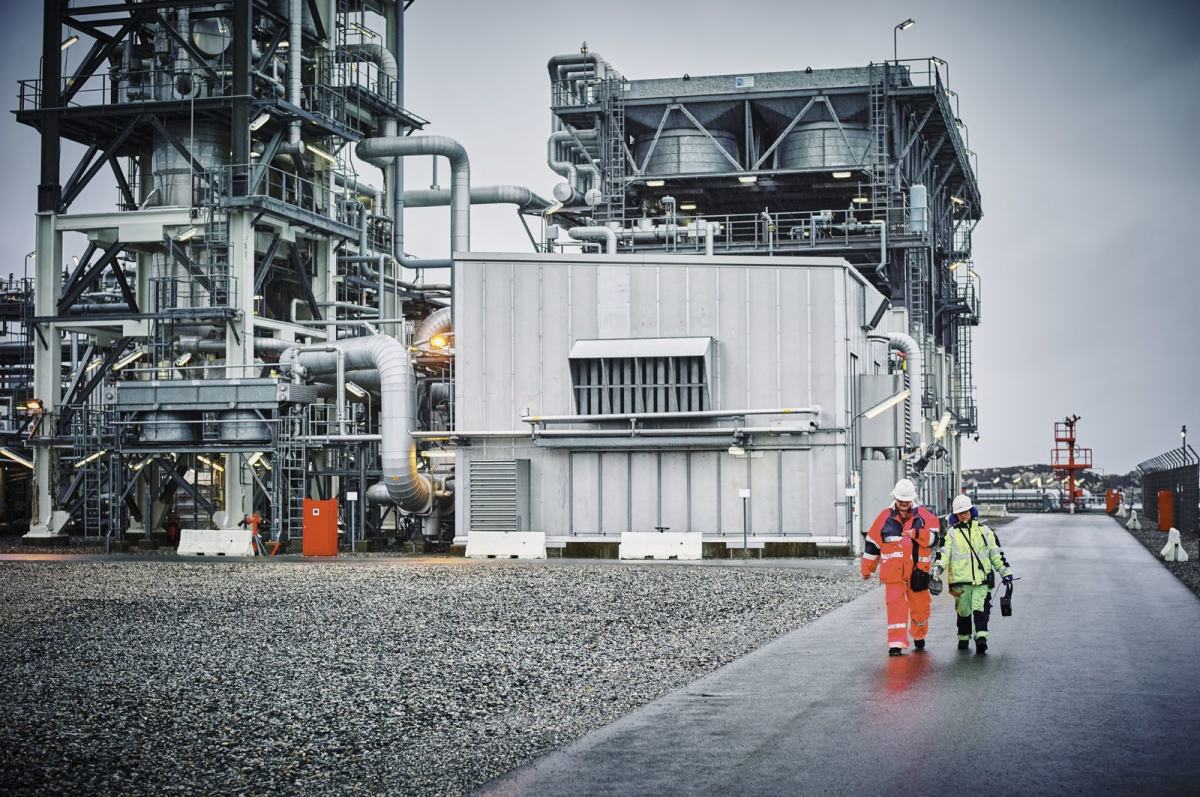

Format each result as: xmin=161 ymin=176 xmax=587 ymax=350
xmin=863 ymin=479 xmax=941 ymax=655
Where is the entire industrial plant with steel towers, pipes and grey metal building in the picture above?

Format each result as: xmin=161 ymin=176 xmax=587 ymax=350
xmin=0 ymin=0 xmax=983 ymax=558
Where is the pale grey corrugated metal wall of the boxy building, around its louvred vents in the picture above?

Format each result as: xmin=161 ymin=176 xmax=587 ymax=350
xmin=454 ymin=254 xmax=881 ymax=538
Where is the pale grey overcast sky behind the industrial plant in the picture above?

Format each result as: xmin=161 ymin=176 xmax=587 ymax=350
xmin=0 ymin=0 xmax=1200 ymax=473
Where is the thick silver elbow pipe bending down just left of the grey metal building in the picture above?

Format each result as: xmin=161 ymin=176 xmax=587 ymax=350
xmin=280 ymin=335 xmax=436 ymax=514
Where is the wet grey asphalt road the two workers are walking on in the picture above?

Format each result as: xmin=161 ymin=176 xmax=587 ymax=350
xmin=481 ymin=515 xmax=1200 ymax=795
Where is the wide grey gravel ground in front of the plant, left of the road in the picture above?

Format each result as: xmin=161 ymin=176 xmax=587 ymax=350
xmin=0 ymin=559 xmax=870 ymax=795
